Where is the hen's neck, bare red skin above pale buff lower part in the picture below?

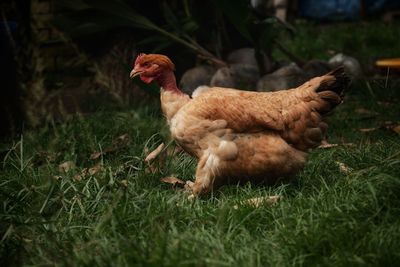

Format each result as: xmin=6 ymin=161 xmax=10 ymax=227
xmin=157 ymin=71 xmax=190 ymax=122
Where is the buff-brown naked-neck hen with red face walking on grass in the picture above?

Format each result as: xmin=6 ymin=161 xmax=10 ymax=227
xmin=130 ymin=54 xmax=349 ymax=196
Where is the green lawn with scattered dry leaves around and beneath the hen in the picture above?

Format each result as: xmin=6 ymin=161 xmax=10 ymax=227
xmin=0 ymin=21 xmax=400 ymax=266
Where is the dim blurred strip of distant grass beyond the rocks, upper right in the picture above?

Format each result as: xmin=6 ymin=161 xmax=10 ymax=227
xmin=275 ymin=21 xmax=400 ymax=65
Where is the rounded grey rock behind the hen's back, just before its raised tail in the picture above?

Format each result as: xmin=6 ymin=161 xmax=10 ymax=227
xmin=257 ymin=63 xmax=308 ymax=92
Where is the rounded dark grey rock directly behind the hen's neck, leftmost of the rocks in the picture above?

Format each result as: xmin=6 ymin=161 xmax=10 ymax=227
xmin=179 ymin=66 xmax=216 ymax=95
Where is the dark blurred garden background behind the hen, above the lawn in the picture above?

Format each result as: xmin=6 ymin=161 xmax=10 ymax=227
xmin=0 ymin=0 xmax=400 ymax=137
